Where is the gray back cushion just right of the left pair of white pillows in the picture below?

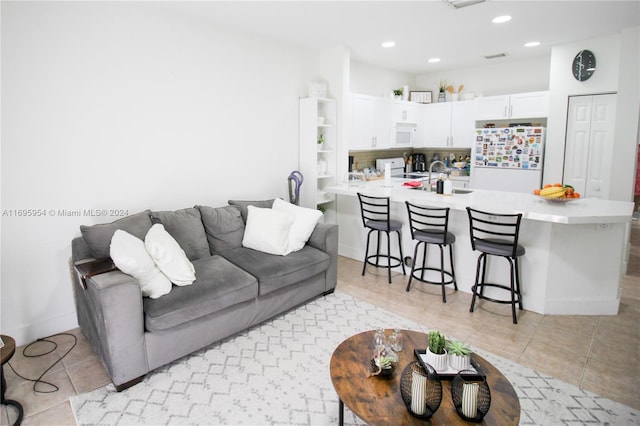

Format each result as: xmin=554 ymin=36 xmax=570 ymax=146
xmin=151 ymin=207 xmax=210 ymax=260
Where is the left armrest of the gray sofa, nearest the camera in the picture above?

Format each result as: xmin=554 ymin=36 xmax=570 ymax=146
xmin=76 ymin=271 xmax=149 ymax=386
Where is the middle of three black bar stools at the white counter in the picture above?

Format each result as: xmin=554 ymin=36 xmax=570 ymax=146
xmin=405 ymin=201 xmax=458 ymax=303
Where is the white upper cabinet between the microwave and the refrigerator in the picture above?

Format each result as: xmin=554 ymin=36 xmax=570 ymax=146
xmin=416 ymin=101 xmax=475 ymax=148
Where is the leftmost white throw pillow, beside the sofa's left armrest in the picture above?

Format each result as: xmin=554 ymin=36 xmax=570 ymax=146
xmin=110 ymin=229 xmax=171 ymax=299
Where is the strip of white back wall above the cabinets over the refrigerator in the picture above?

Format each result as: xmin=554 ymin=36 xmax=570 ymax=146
xmin=416 ymin=55 xmax=550 ymax=97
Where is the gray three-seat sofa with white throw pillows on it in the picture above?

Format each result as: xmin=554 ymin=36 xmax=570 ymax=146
xmin=71 ymin=200 xmax=338 ymax=391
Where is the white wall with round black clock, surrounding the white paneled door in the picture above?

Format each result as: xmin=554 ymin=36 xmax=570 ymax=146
xmin=544 ymin=27 xmax=640 ymax=201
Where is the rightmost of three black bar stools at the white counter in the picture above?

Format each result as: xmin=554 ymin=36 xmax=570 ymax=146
xmin=467 ymin=207 xmax=525 ymax=324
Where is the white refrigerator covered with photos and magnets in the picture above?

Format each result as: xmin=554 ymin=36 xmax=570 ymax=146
xmin=469 ymin=126 xmax=545 ymax=193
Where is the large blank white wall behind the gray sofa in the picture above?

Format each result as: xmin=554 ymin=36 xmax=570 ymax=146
xmin=0 ymin=2 xmax=318 ymax=344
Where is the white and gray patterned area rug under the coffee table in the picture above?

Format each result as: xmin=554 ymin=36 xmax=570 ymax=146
xmin=70 ymin=293 xmax=640 ymax=425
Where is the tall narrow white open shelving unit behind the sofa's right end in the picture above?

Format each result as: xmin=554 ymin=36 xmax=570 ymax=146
xmin=298 ymin=98 xmax=338 ymax=223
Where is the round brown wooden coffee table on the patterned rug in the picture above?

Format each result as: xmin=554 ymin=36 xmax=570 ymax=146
xmin=330 ymin=330 xmax=520 ymax=425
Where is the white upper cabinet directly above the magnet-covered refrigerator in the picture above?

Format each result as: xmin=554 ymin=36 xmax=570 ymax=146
xmin=475 ymin=91 xmax=549 ymax=120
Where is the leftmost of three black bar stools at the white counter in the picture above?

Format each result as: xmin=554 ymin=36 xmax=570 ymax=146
xmin=358 ymin=193 xmax=407 ymax=284
